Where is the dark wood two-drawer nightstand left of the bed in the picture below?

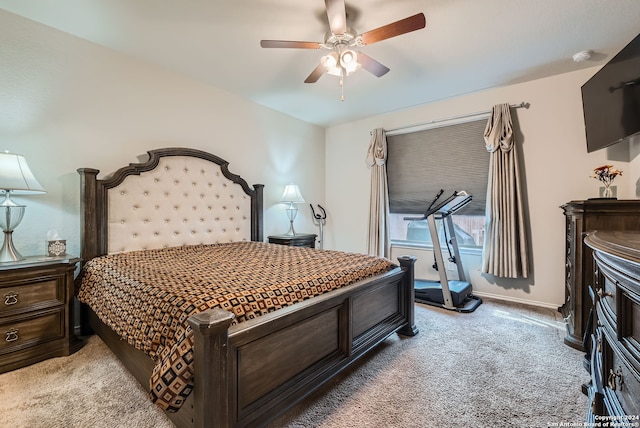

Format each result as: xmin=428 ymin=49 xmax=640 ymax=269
xmin=0 ymin=256 xmax=83 ymax=373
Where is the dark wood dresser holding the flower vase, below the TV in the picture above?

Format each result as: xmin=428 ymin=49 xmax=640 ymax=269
xmin=559 ymin=199 xmax=640 ymax=350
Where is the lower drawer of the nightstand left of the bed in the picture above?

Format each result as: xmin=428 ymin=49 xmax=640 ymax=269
xmin=0 ymin=307 xmax=65 ymax=354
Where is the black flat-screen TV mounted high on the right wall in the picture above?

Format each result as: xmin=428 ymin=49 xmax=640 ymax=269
xmin=582 ymin=35 xmax=640 ymax=153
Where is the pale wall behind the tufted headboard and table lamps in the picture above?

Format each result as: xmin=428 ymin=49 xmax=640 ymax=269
xmin=0 ymin=10 xmax=325 ymax=255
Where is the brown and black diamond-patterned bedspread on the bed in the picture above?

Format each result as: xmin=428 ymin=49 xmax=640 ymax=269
xmin=78 ymin=242 xmax=395 ymax=411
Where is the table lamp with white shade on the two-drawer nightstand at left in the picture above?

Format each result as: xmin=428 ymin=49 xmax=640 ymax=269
xmin=0 ymin=152 xmax=45 ymax=263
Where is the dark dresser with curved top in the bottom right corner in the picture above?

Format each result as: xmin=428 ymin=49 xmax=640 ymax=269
xmin=584 ymin=231 xmax=640 ymax=426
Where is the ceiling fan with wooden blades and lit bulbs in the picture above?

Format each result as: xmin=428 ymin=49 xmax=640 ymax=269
xmin=260 ymin=0 xmax=426 ymax=100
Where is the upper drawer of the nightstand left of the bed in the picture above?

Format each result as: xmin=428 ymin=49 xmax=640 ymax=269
xmin=0 ymin=278 xmax=64 ymax=315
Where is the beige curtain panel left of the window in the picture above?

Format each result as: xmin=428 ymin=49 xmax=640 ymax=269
xmin=366 ymin=128 xmax=391 ymax=258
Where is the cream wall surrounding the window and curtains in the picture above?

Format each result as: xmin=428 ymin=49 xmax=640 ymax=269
xmin=325 ymin=68 xmax=640 ymax=307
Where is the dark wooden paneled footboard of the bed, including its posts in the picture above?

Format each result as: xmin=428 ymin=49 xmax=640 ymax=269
xmin=189 ymin=257 xmax=417 ymax=427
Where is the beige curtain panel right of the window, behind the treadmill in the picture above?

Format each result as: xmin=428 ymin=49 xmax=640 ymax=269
xmin=482 ymin=104 xmax=530 ymax=278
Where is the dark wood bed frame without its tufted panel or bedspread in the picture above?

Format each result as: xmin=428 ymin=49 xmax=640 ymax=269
xmin=78 ymin=148 xmax=418 ymax=427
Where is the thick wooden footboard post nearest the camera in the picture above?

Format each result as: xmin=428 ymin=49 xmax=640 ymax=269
xmin=187 ymin=308 xmax=236 ymax=428
